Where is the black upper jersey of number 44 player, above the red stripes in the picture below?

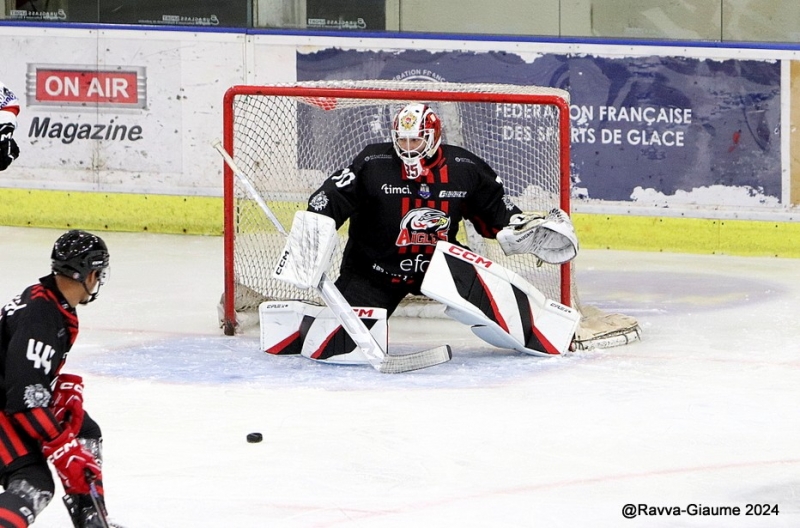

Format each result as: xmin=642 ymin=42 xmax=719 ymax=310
xmin=0 ymin=275 xmax=78 ymax=414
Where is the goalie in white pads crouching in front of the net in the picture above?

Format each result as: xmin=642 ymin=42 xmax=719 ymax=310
xmin=262 ymin=103 xmax=580 ymax=363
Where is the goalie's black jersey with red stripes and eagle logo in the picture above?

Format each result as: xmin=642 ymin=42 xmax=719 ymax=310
xmin=308 ymin=143 xmax=521 ymax=280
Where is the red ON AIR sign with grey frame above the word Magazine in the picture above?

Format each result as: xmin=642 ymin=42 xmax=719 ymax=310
xmin=27 ymin=64 xmax=147 ymax=108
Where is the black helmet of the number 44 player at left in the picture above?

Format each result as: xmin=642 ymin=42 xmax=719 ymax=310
xmin=50 ymin=229 xmax=108 ymax=283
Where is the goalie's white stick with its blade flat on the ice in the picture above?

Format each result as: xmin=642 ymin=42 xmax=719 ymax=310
xmin=212 ymin=139 xmax=453 ymax=374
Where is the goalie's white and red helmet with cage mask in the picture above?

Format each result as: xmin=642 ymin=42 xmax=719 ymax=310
xmin=392 ymin=103 xmax=442 ymax=163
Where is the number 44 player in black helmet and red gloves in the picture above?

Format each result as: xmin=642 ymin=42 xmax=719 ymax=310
xmin=0 ymin=230 xmax=109 ymax=528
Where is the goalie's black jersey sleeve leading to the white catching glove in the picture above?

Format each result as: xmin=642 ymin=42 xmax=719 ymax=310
xmin=464 ymin=157 xmax=522 ymax=238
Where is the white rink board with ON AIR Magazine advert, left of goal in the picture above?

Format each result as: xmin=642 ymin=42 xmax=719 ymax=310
xmin=0 ymin=28 xmax=243 ymax=195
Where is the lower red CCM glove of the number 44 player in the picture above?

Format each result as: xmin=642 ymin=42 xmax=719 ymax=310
xmin=42 ymin=429 xmax=102 ymax=494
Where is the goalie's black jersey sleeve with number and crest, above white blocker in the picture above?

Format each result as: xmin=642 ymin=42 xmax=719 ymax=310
xmin=307 ymin=146 xmax=366 ymax=229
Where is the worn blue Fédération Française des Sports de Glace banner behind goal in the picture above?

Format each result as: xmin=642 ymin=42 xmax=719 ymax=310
xmin=297 ymin=48 xmax=781 ymax=206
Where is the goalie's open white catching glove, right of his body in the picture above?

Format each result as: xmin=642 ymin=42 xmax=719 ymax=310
xmin=497 ymin=209 xmax=578 ymax=264
